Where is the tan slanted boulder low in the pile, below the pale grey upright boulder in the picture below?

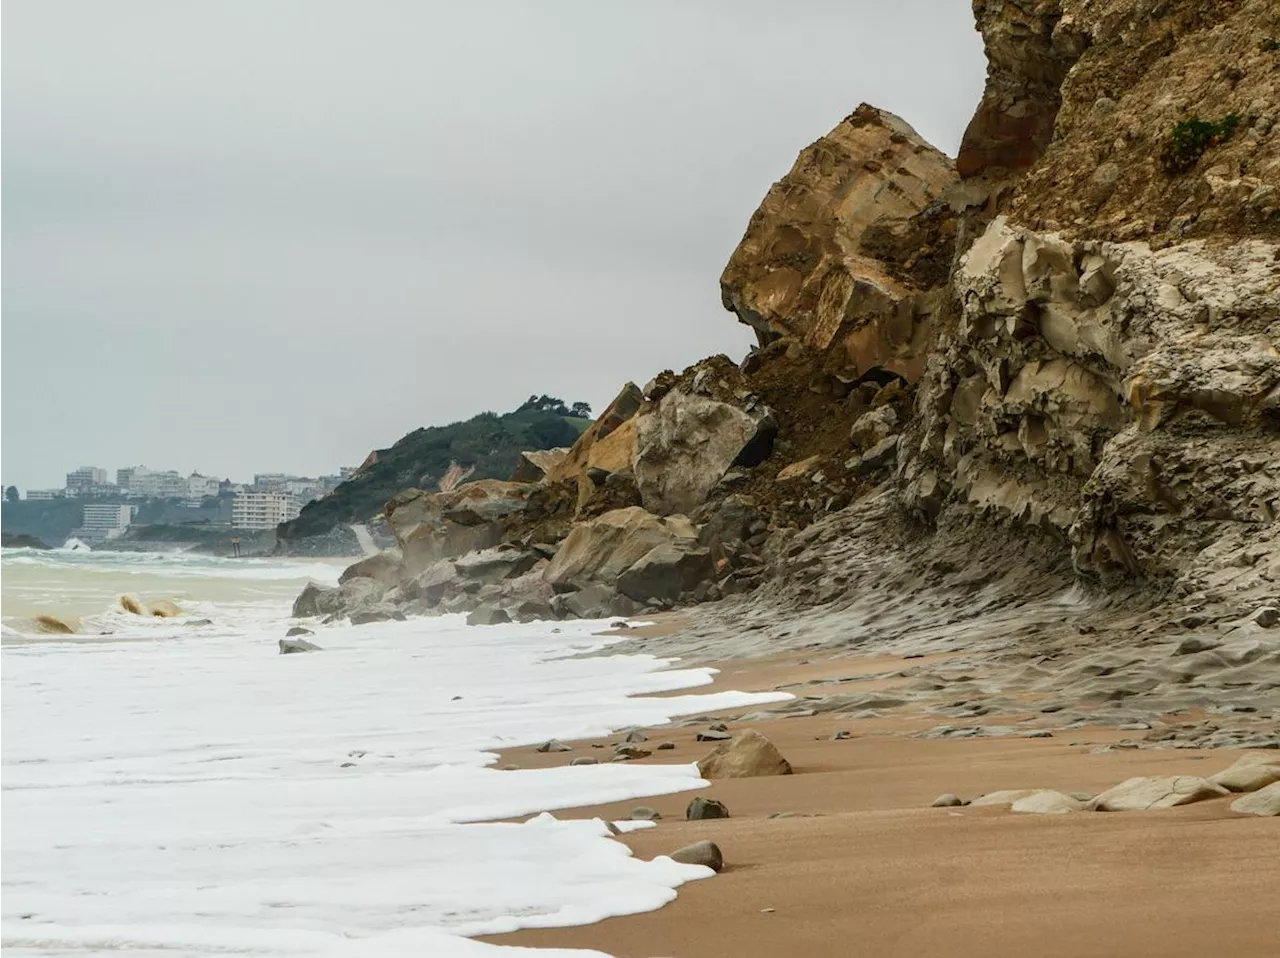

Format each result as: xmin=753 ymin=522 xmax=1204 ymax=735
xmin=543 ymin=506 xmax=699 ymax=592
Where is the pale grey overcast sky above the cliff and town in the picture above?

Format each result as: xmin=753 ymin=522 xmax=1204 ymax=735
xmin=0 ymin=0 xmax=984 ymax=488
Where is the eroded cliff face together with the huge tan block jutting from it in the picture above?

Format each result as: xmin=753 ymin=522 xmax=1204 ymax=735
xmin=722 ymin=0 xmax=1280 ymax=609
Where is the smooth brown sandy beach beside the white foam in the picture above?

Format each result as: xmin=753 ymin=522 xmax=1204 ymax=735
xmin=489 ymin=642 xmax=1280 ymax=958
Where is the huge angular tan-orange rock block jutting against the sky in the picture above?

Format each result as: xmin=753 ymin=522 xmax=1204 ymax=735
xmin=721 ymin=105 xmax=956 ymax=379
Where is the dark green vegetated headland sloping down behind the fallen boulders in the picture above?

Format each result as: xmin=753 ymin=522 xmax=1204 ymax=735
xmin=279 ymin=396 xmax=591 ymax=540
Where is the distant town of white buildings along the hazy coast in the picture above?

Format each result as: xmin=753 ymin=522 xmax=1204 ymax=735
xmin=0 ymin=466 xmax=355 ymax=542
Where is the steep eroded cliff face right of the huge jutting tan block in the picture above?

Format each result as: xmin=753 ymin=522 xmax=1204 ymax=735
xmin=900 ymin=0 xmax=1280 ymax=593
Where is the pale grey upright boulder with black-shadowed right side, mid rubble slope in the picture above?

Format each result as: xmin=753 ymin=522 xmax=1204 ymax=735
xmin=635 ymin=389 xmax=778 ymax=515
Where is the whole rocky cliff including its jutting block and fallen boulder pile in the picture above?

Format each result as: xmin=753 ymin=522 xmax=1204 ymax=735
xmin=294 ymin=0 xmax=1280 ymax=654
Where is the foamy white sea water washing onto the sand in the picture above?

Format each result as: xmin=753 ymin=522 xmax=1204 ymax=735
xmin=0 ymin=553 xmax=786 ymax=958
